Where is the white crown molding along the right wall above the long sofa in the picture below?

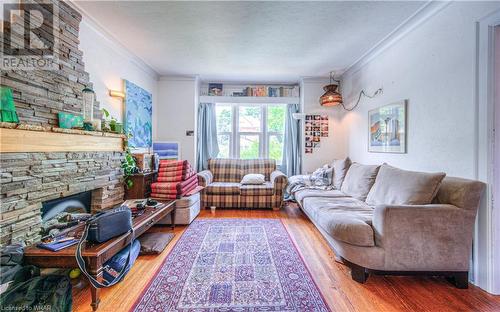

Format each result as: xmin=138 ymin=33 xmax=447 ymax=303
xmin=342 ymin=0 xmax=453 ymax=75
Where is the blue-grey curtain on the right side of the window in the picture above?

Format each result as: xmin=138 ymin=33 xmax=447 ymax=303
xmin=281 ymin=104 xmax=302 ymax=177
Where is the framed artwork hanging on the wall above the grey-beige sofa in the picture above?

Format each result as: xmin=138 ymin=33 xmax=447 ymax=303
xmin=368 ymin=100 xmax=407 ymax=153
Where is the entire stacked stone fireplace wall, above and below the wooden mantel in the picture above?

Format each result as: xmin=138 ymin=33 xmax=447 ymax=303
xmin=0 ymin=0 xmax=124 ymax=246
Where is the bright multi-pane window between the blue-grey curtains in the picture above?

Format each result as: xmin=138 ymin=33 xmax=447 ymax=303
xmin=216 ymin=104 xmax=286 ymax=165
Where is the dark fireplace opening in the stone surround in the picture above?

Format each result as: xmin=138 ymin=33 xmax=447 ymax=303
xmin=41 ymin=191 xmax=92 ymax=236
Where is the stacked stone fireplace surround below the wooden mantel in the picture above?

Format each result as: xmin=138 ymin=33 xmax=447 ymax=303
xmin=0 ymin=152 xmax=124 ymax=246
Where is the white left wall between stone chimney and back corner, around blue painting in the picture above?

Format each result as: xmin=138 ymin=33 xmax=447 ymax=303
xmin=79 ymin=16 xmax=158 ymax=138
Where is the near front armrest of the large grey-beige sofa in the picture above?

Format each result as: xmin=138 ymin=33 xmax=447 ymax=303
xmin=372 ymin=204 xmax=474 ymax=271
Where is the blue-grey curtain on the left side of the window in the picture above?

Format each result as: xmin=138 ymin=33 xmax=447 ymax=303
xmin=196 ymin=103 xmax=219 ymax=172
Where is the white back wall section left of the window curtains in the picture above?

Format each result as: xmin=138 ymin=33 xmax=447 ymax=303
xmin=156 ymin=77 xmax=198 ymax=166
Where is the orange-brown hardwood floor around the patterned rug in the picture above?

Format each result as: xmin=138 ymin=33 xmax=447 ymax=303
xmin=73 ymin=206 xmax=500 ymax=312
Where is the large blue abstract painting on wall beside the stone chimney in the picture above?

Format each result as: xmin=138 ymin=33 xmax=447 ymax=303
xmin=125 ymin=80 xmax=153 ymax=148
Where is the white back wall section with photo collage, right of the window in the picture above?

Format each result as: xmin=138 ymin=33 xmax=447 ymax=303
xmin=300 ymin=78 xmax=347 ymax=173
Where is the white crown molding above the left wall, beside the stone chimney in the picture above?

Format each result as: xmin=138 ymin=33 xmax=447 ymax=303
xmin=68 ymin=0 xmax=160 ymax=80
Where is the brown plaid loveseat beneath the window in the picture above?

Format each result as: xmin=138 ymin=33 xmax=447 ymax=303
xmin=198 ymin=158 xmax=288 ymax=210
